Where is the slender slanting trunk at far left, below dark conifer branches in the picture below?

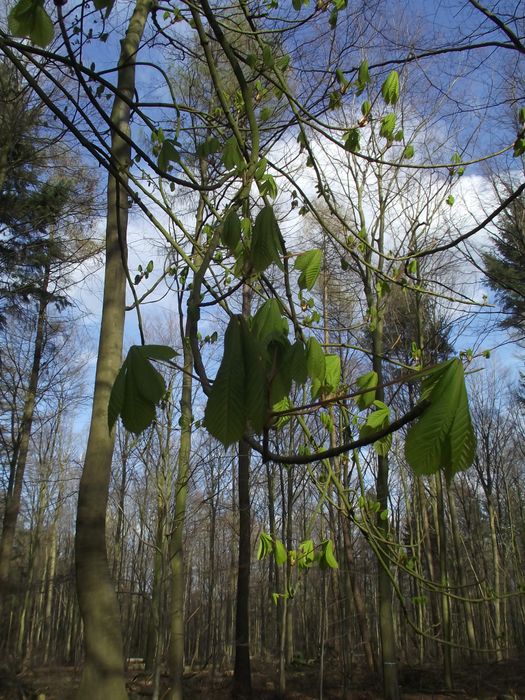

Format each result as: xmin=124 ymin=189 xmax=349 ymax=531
xmin=0 ymin=263 xmax=50 ymax=601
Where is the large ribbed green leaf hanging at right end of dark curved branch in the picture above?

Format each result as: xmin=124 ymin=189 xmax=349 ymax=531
xmin=405 ymin=359 xmax=476 ymax=482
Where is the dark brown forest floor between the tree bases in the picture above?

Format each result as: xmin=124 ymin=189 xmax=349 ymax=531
xmin=0 ymin=658 xmax=525 ymax=700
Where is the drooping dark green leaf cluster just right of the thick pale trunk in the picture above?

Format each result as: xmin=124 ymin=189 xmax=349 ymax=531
xmin=108 ymin=345 xmax=177 ymax=433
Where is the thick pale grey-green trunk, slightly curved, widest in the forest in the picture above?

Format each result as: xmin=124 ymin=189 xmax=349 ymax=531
xmin=75 ymin=0 xmax=151 ymax=700
